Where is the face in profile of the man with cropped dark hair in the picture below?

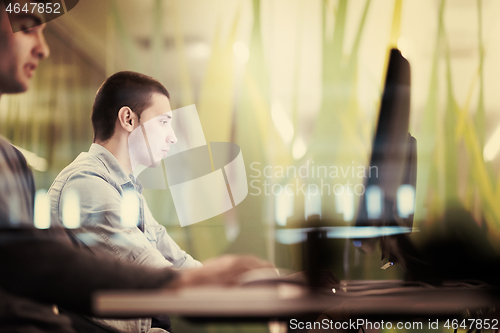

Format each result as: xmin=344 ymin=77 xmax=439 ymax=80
xmin=132 ymin=93 xmax=177 ymax=167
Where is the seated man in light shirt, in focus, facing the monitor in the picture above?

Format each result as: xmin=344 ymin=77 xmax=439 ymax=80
xmin=48 ymin=72 xmax=201 ymax=333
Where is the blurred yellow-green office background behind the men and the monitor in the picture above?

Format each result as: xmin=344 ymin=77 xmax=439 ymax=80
xmin=0 ymin=0 xmax=500 ymax=330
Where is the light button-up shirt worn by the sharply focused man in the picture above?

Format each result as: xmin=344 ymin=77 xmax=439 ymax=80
xmin=48 ymin=144 xmax=201 ymax=268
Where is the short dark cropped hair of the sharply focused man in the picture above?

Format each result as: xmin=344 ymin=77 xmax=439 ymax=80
xmin=91 ymin=71 xmax=170 ymax=142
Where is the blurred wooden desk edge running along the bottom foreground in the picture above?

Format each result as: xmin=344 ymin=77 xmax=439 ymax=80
xmin=94 ymin=285 xmax=500 ymax=319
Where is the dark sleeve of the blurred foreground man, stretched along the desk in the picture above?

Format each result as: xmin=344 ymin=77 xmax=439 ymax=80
xmin=0 ymin=228 xmax=178 ymax=314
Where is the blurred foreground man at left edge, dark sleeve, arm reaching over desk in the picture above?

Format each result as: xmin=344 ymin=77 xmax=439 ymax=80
xmin=0 ymin=1 xmax=269 ymax=332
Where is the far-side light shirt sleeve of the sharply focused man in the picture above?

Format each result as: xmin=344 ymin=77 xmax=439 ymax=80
xmin=144 ymin=202 xmax=202 ymax=268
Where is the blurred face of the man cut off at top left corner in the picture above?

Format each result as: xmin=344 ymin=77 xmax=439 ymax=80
xmin=0 ymin=1 xmax=49 ymax=94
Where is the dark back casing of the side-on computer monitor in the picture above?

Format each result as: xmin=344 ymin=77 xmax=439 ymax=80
xmin=354 ymin=49 xmax=416 ymax=257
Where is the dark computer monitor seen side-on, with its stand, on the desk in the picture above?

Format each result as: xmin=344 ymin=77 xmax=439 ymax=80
xmin=354 ymin=49 xmax=417 ymax=265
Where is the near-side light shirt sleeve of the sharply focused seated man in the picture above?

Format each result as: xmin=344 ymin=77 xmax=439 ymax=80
xmin=58 ymin=172 xmax=172 ymax=268
